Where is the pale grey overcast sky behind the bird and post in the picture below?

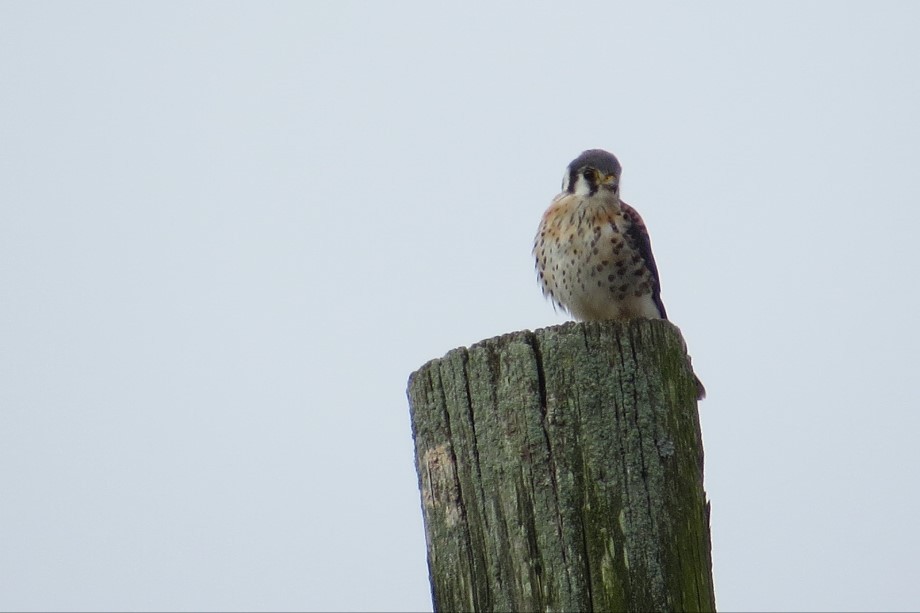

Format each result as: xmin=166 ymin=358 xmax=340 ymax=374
xmin=0 ymin=2 xmax=920 ymax=611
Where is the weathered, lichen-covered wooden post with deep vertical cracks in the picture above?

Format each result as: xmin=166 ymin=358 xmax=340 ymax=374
xmin=408 ymin=319 xmax=715 ymax=611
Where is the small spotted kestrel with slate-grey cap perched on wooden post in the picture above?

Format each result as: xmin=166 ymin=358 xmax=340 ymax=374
xmin=533 ymin=149 xmax=668 ymax=321
